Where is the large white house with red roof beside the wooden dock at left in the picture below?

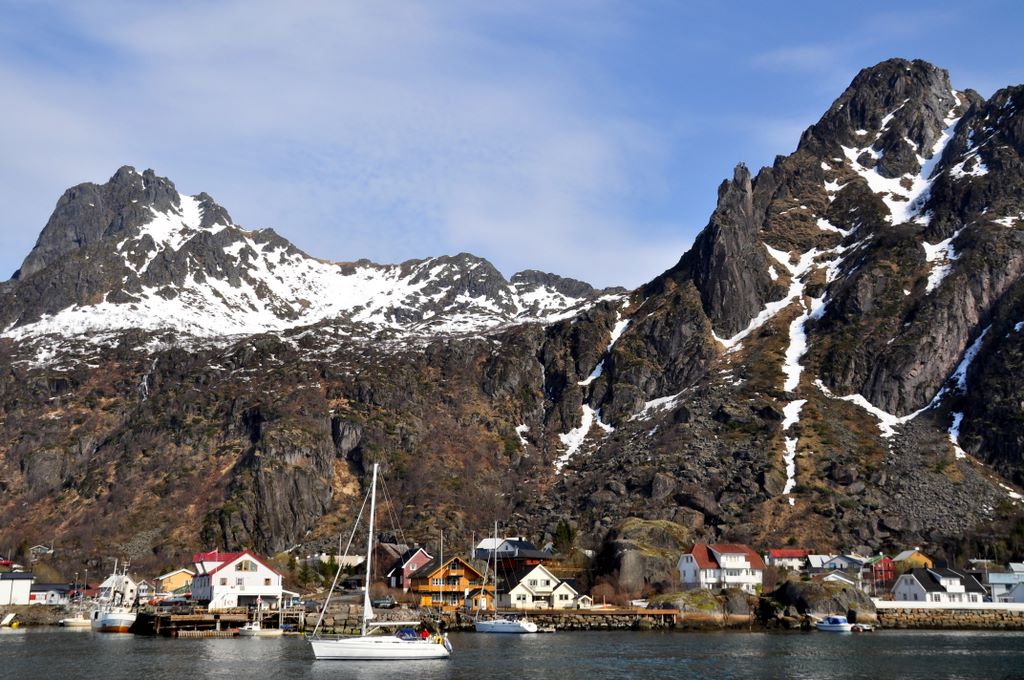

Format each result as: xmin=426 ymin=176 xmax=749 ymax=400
xmin=191 ymin=550 xmax=283 ymax=609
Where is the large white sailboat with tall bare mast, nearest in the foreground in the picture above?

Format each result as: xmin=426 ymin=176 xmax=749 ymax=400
xmin=309 ymin=463 xmax=452 ymax=661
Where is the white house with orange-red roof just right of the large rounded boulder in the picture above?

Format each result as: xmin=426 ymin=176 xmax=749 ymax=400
xmin=679 ymin=543 xmax=765 ymax=593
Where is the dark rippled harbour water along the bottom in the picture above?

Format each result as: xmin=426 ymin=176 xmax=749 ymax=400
xmin=0 ymin=628 xmax=1024 ymax=680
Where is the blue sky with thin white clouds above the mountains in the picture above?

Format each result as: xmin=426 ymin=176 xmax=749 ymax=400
xmin=0 ymin=0 xmax=1024 ymax=287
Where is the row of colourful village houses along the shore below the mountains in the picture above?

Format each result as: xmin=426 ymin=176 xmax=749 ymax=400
xmin=0 ymin=537 xmax=1024 ymax=636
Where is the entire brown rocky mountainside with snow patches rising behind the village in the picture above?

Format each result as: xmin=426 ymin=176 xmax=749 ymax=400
xmin=0 ymin=59 xmax=1024 ymax=577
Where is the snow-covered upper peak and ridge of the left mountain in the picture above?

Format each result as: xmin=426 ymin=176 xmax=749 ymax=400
xmin=0 ymin=167 xmax=614 ymax=346
